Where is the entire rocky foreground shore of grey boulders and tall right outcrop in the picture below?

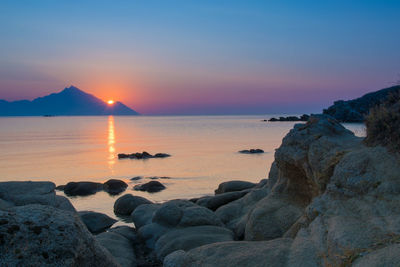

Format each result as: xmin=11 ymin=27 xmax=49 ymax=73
xmin=0 ymin=115 xmax=400 ymax=267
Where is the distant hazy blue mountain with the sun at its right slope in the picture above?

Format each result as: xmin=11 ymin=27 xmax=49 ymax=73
xmin=0 ymin=86 xmax=139 ymax=116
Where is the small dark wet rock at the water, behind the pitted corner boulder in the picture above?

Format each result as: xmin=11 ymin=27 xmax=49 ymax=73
xmin=78 ymin=211 xmax=117 ymax=234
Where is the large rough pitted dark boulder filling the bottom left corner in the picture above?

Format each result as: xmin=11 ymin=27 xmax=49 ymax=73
xmin=0 ymin=204 xmax=118 ymax=266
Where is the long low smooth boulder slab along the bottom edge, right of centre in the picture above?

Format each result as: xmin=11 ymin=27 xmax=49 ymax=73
xmin=164 ymin=238 xmax=292 ymax=267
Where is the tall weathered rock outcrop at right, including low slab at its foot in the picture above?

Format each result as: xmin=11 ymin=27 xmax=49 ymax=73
xmin=164 ymin=115 xmax=400 ymax=267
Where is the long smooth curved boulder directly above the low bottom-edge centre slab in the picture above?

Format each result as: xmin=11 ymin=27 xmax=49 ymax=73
xmin=155 ymin=226 xmax=234 ymax=260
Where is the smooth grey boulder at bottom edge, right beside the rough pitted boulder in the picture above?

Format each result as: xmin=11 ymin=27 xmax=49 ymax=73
xmin=96 ymin=232 xmax=136 ymax=267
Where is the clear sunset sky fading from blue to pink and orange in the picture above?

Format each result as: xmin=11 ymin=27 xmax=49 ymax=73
xmin=0 ymin=0 xmax=400 ymax=115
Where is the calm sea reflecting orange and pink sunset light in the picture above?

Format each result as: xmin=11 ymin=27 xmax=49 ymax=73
xmin=0 ymin=116 xmax=365 ymax=222
